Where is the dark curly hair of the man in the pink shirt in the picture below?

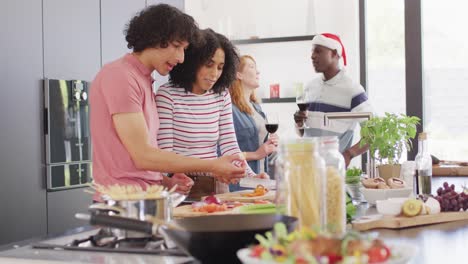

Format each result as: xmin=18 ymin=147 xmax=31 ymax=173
xmin=124 ymin=4 xmax=200 ymax=52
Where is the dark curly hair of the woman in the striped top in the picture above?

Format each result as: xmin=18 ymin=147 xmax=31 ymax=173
xmin=169 ymin=29 xmax=239 ymax=93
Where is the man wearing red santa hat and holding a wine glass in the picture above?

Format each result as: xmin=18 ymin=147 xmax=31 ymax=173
xmin=294 ymin=33 xmax=372 ymax=166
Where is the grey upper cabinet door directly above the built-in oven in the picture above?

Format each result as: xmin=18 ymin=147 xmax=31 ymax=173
xmin=43 ymin=0 xmax=101 ymax=81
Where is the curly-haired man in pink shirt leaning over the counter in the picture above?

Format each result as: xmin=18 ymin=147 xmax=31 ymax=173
xmin=90 ymin=4 xmax=245 ymax=198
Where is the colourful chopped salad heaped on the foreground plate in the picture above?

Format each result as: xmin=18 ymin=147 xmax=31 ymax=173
xmin=250 ymin=223 xmax=391 ymax=264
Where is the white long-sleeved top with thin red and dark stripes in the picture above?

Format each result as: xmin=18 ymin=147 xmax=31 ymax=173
xmin=156 ymin=84 xmax=255 ymax=189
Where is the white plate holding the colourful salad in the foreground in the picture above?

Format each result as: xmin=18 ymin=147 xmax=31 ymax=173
xmin=237 ymin=242 xmax=419 ymax=264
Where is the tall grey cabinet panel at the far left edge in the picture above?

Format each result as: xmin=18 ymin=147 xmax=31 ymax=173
xmin=0 ymin=0 xmax=47 ymax=244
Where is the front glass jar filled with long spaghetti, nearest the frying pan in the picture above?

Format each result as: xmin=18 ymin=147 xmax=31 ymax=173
xmin=275 ymin=138 xmax=326 ymax=229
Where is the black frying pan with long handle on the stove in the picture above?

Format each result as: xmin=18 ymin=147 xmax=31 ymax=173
xmin=84 ymin=214 xmax=297 ymax=263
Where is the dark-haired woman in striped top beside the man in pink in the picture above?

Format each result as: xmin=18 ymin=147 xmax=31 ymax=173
xmin=156 ymin=29 xmax=268 ymax=198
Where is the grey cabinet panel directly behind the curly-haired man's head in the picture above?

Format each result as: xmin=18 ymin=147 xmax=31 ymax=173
xmin=101 ymin=0 xmax=146 ymax=66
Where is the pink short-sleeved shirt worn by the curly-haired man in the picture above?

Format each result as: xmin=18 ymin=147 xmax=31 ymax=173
xmin=90 ymin=54 xmax=162 ymax=188
